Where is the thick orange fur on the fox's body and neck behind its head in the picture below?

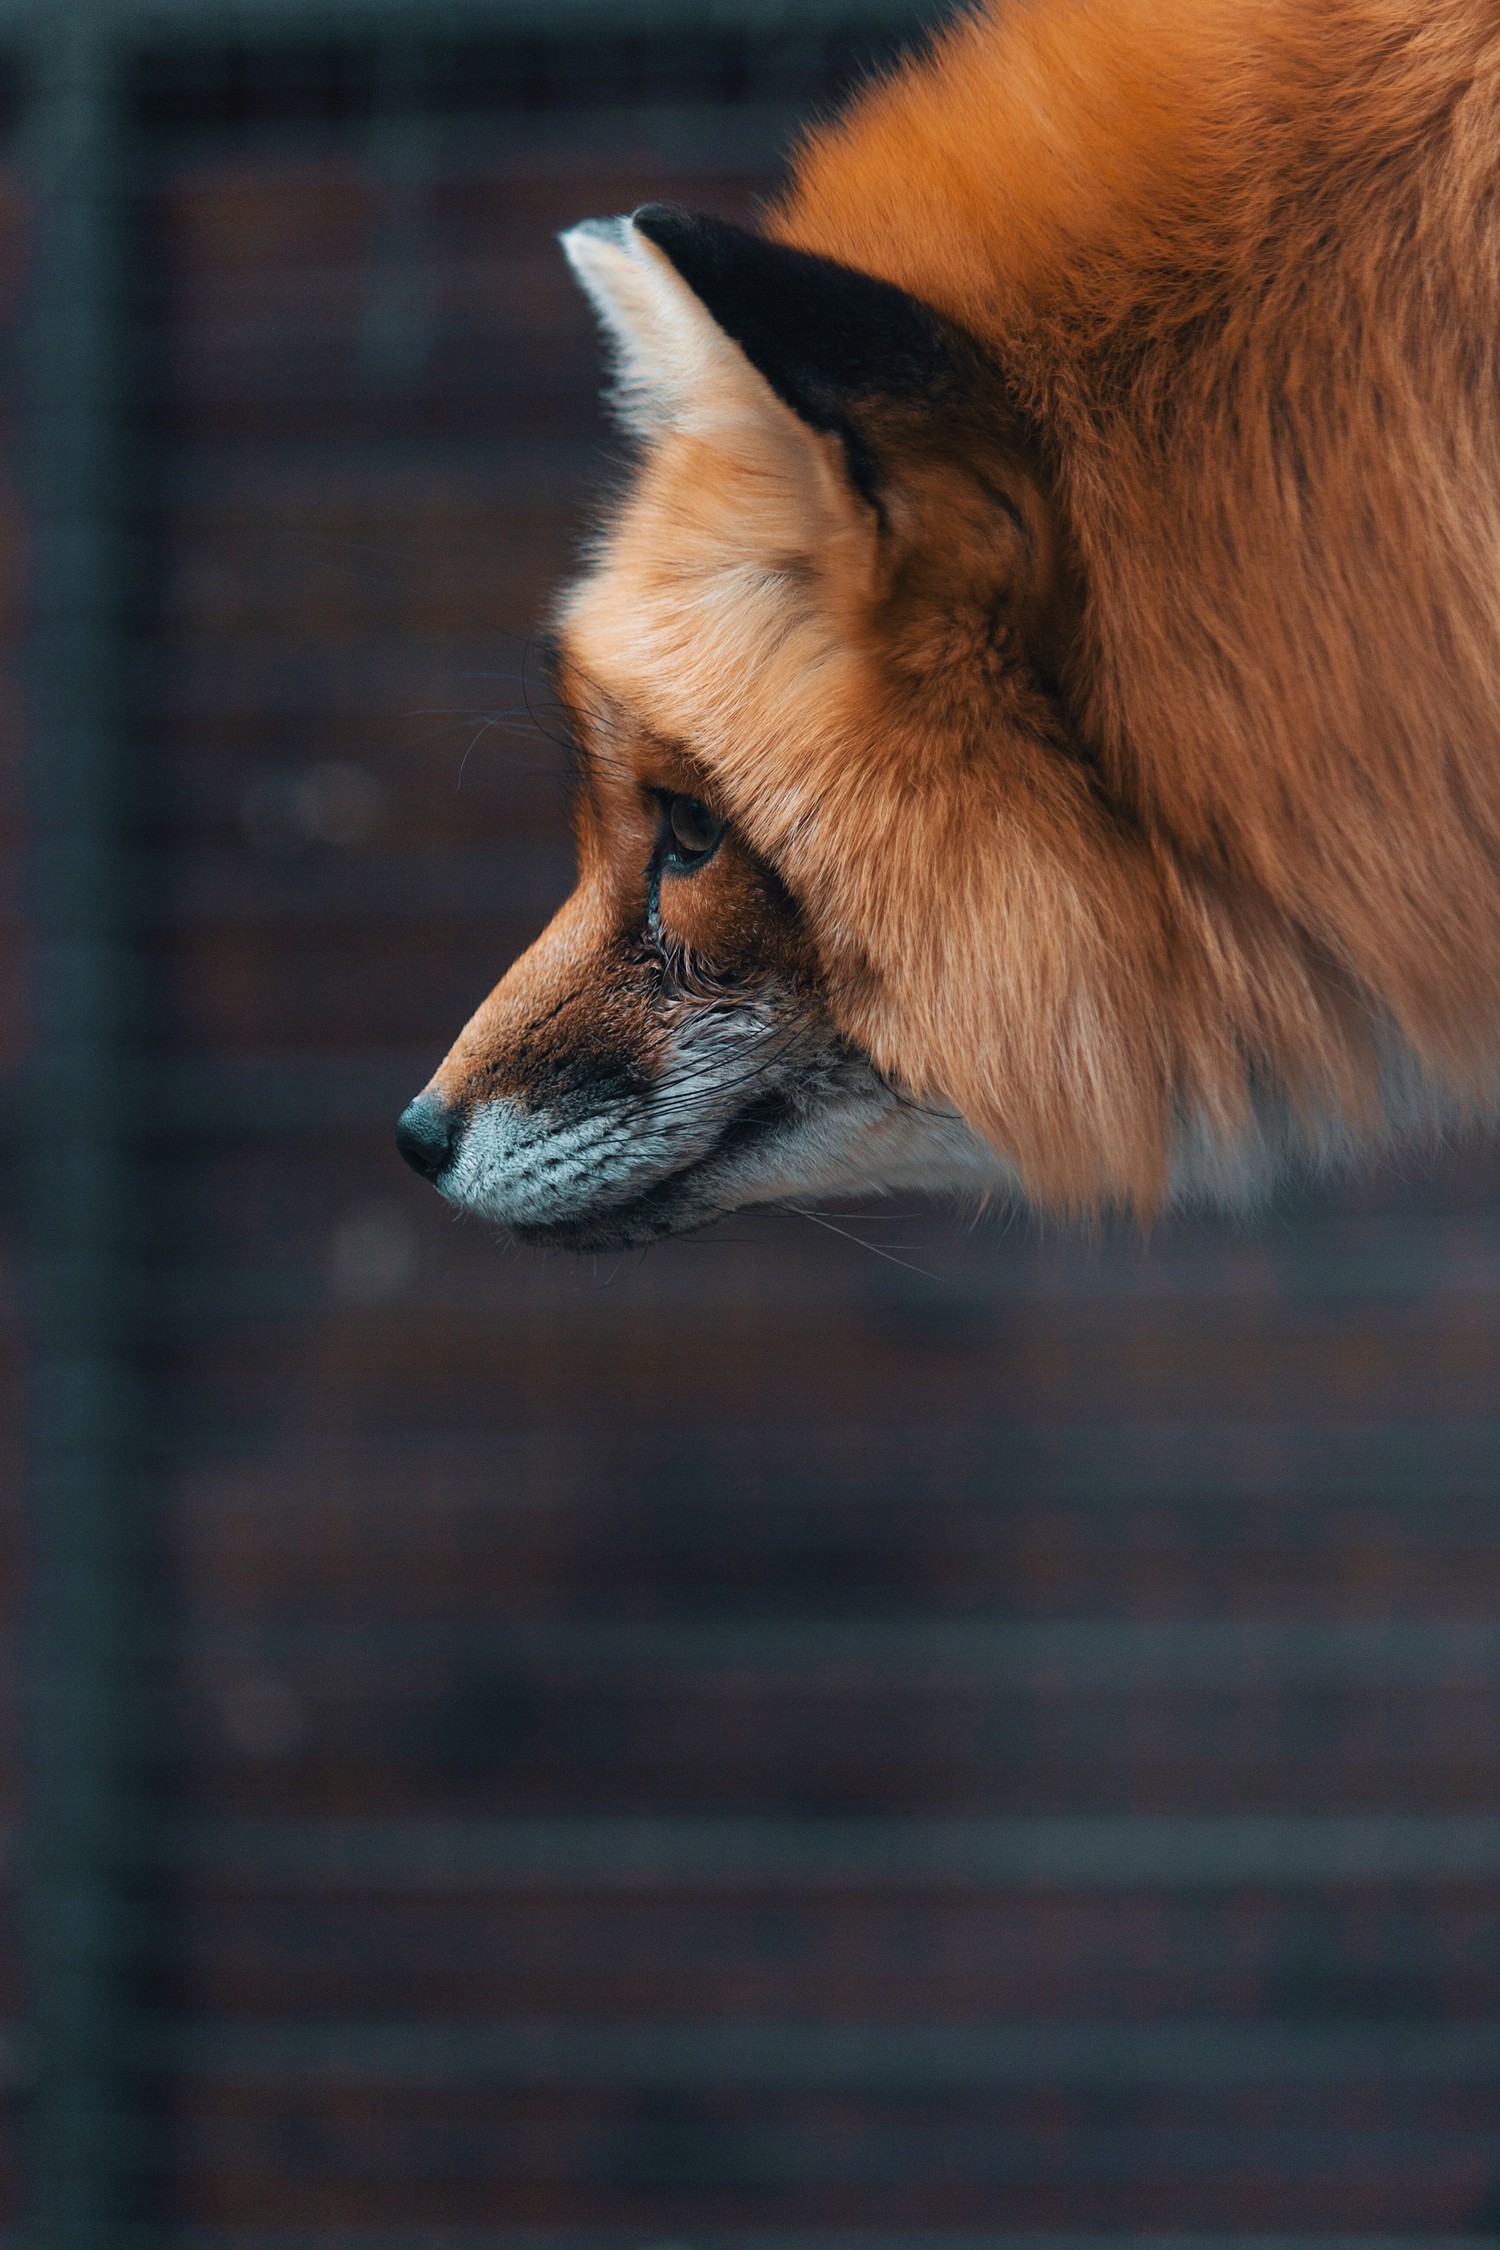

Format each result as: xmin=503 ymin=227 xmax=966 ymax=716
xmin=755 ymin=0 xmax=1500 ymax=1199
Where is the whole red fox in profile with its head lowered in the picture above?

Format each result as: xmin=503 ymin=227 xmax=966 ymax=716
xmin=398 ymin=0 xmax=1500 ymax=1247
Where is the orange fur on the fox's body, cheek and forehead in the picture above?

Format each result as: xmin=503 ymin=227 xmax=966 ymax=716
xmin=413 ymin=0 xmax=1500 ymax=1211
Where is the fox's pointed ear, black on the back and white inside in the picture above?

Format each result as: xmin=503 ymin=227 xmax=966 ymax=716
xmin=562 ymin=203 xmax=963 ymax=497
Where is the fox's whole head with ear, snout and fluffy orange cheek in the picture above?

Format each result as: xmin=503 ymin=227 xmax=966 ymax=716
xmin=398 ymin=205 xmax=1379 ymax=1249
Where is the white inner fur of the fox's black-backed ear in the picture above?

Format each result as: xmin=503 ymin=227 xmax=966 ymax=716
xmin=562 ymin=218 xmax=825 ymax=475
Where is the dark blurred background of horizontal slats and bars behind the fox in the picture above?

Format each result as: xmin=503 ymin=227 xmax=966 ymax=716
xmin=0 ymin=0 xmax=1500 ymax=2250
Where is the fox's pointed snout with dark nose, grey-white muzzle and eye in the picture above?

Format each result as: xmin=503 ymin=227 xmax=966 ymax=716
xmin=396 ymin=776 xmax=891 ymax=1249
